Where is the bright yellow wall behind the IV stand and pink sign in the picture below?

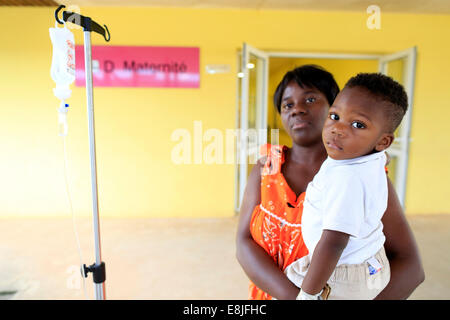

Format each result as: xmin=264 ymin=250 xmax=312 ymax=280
xmin=0 ymin=7 xmax=450 ymax=217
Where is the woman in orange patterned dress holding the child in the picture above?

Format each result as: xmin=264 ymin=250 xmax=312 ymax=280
xmin=236 ymin=65 xmax=424 ymax=299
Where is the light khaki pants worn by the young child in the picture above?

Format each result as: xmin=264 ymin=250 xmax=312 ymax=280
xmin=284 ymin=248 xmax=391 ymax=300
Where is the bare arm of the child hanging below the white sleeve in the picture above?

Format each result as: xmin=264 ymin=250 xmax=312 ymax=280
xmin=302 ymin=230 xmax=349 ymax=295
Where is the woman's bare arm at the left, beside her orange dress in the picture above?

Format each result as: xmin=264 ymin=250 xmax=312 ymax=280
xmin=236 ymin=162 xmax=300 ymax=299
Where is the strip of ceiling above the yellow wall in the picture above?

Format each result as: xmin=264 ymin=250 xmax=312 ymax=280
xmin=56 ymin=0 xmax=450 ymax=14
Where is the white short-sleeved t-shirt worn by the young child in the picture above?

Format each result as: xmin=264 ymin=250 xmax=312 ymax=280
xmin=302 ymin=151 xmax=388 ymax=265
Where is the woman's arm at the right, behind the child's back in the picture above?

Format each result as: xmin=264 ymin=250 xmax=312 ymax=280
xmin=375 ymin=178 xmax=425 ymax=300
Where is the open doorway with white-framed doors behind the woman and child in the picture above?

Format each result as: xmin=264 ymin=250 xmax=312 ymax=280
xmin=234 ymin=43 xmax=417 ymax=213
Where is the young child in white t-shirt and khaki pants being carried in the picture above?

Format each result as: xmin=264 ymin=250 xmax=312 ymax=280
xmin=285 ymin=73 xmax=408 ymax=300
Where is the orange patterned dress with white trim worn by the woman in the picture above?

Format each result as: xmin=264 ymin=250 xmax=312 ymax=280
xmin=249 ymin=144 xmax=308 ymax=300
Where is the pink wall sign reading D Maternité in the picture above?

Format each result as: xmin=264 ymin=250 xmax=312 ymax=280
xmin=75 ymin=46 xmax=200 ymax=88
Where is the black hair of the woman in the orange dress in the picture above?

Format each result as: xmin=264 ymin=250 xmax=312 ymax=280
xmin=273 ymin=64 xmax=339 ymax=113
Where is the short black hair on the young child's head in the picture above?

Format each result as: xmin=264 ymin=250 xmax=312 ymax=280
xmin=344 ymin=73 xmax=408 ymax=132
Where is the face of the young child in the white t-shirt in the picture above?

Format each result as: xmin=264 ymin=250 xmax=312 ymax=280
xmin=322 ymin=87 xmax=394 ymax=160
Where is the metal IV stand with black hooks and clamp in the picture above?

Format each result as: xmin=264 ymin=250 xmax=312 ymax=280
xmin=55 ymin=5 xmax=111 ymax=300
